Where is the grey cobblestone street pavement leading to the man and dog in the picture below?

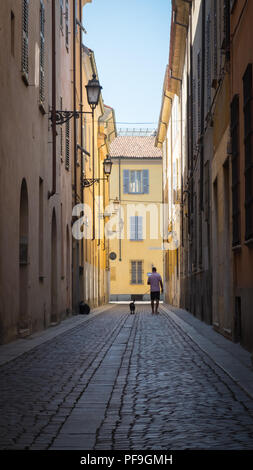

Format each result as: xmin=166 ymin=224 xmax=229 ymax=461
xmin=0 ymin=305 xmax=253 ymax=450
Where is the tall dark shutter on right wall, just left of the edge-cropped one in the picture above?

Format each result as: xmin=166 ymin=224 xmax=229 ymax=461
xmin=230 ymin=95 xmax=240 ymax=246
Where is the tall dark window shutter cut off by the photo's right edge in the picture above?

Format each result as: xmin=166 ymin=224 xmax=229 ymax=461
xmin=243 ymin=64 xmax=253 ymax=240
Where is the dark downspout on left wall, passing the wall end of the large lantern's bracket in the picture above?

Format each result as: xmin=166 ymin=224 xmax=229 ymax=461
xmin=48 ymin=0 xmax=57 ymax=199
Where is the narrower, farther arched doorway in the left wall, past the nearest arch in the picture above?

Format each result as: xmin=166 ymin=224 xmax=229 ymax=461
xmin=51 ymin=209 xmax=58 ymax=323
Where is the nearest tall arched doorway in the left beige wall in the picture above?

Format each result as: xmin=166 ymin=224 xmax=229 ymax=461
xmin=18 ymin=179 xmax=30 ymax=335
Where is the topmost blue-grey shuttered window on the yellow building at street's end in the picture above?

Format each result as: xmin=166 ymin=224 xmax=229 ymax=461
xmin=123 ymin=170 xmax=149 ymax=194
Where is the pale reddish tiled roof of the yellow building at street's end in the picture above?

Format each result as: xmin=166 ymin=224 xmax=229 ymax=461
xmin=110 ymin=135 xmax=162 ymax=158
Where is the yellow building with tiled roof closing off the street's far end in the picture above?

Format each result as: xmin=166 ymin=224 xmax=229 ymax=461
xmin=106 ymin=135 xmax=163 ymax=301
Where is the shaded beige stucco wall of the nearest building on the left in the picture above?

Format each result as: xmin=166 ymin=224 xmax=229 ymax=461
xmin=0 ymin=0 xmax=71 ymax=342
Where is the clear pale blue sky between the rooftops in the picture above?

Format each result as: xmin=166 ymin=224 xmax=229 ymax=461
xmin=83 ymin=0 xmax=171 ymax=128
